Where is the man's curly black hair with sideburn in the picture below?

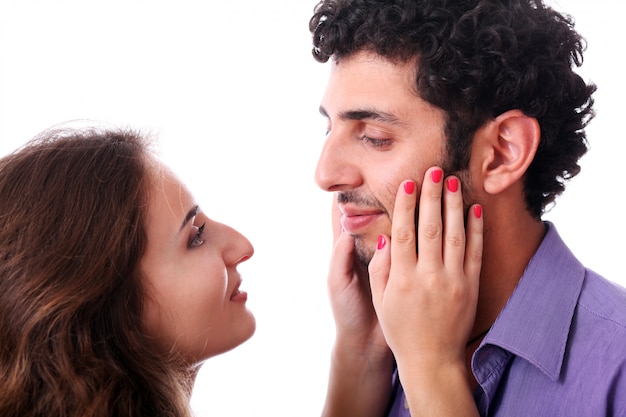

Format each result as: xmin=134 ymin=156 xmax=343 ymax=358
xmin=309 ymin=0 xmax=596 ymax=217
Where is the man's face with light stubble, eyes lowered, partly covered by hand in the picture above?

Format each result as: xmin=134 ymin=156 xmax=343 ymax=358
xmin=315 ymin=52 xmax=447 ymax=264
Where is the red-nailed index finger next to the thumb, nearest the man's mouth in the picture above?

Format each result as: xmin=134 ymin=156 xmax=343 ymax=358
xmin=391 ymin=180 xmax=417 ymax=266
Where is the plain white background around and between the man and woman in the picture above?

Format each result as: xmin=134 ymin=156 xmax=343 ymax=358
xmin=0 ymin=0 xmax=626 ymax=416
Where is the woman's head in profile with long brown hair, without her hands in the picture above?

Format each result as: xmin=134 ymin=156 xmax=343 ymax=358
xmin=0 ymin=128 xmax=255 ymax=417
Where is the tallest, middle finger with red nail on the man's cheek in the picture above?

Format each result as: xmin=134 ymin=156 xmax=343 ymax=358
xmin=417 ymin=167 xmax=443 ymax=267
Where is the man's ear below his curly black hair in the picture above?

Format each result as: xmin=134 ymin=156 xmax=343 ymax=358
xmin=475 ymin=110 xmax=541 ymax=194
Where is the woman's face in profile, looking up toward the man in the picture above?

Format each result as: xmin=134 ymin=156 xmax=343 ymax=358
xmin=140 ymin=162 xmax=256 ymax=363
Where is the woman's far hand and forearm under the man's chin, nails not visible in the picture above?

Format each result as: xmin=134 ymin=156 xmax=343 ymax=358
xmin=322 ymin=198 xmax=393 ymax=417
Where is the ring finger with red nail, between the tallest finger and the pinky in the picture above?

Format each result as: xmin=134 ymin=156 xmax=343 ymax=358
xmin=443 ymin=176 xmax=465 ymax=266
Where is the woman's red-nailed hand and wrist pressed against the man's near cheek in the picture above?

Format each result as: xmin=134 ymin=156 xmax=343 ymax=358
xmin=369 ymin=167 xmax=483 ymax=416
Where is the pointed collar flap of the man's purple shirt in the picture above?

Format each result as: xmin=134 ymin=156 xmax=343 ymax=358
xmin=481 ymin=222 xmax=585 ymax=381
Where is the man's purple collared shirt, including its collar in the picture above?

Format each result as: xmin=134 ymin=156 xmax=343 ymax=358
xmin=388 ymin=222 xmax=626 ymax=417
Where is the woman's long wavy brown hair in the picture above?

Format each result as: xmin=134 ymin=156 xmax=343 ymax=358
xmin=0 ymin=128 xmax=193 ymax=417
